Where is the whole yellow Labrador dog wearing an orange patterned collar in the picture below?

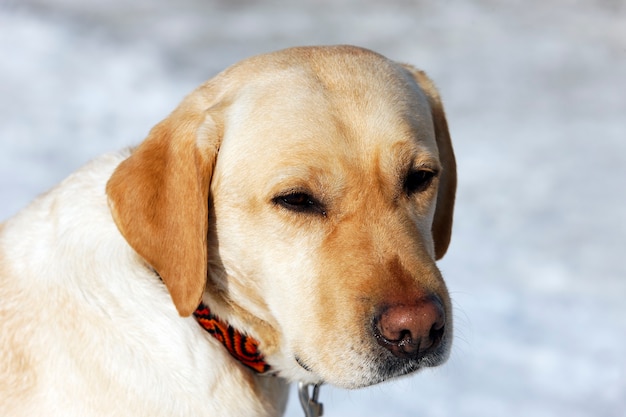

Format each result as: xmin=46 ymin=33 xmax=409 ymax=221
xmin=0 ymin=46 xmax=456 ymax=417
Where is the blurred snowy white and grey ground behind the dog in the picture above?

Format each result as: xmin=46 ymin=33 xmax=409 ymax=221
xmin=0 ymin=0 xmax=626 ymax=417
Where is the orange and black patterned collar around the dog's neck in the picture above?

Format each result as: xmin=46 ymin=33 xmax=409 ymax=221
xmin=193 ymin=303 xmax=270 ymax=374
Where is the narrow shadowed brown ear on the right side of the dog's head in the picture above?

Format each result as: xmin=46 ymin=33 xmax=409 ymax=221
xmin=403 ymin=65 xmax=456 ymax=259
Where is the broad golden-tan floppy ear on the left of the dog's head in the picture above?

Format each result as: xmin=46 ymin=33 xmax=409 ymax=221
xmin=106 ymin=99 xmax=221 ymax=316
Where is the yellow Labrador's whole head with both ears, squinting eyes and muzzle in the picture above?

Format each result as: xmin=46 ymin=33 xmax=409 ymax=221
xmin=107 ymin=47 xmax=456 ymax=387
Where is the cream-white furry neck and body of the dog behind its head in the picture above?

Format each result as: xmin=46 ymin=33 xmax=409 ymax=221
xmin=0 ymin=153 xmax=286 ymax=417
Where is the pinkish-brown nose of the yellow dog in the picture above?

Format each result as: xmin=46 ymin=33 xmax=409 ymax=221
xmin=374 ymin=297 xmax=446 ymax=359
